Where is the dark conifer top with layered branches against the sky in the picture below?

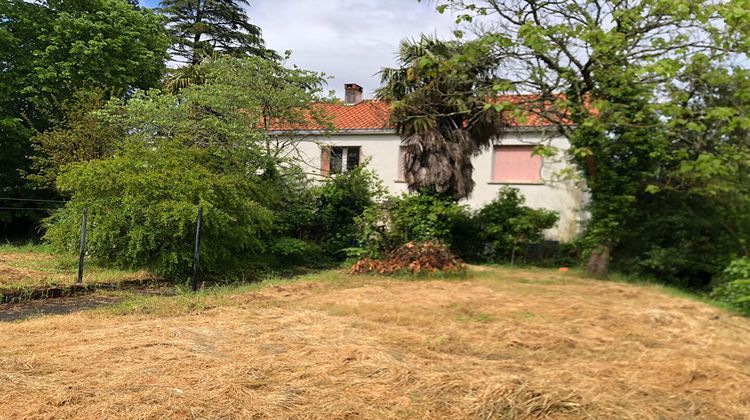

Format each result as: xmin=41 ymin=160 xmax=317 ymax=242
xmin=160 ymin=0 xmax=275 ymax=64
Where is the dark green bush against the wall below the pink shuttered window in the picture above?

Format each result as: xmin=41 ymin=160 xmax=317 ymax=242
xmin=475 ymin=187 xmax=558 ymax=263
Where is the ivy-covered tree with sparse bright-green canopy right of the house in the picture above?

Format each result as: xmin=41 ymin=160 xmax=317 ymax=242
xmin=438 ymin=0 xmax=748 ymax=274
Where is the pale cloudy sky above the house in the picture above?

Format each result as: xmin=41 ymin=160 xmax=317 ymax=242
xmin=141 ymin=0 xmax=455 ymax=97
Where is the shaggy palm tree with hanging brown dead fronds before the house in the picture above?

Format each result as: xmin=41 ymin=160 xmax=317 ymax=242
xmin=376 ymin=35 xmax=508 ymax=200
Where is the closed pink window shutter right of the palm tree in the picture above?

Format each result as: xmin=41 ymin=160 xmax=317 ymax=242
xmin=492 ymin=146 xmax=542 ymax=182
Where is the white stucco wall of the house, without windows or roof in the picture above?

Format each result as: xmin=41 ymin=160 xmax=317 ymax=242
xmin=290 ymin=130 xmax=584 ymax=241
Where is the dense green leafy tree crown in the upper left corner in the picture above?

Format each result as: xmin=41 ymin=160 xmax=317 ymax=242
xmin=0 ymin=0 xmax=169 ymax=116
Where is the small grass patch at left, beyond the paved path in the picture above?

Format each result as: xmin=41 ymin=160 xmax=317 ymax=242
xmin=0 ymin=245 xmax=152 ymax=293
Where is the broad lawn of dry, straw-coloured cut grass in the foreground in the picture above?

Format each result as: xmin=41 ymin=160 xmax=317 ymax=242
xmin=0 ymin=267 xmax=750 ymax=419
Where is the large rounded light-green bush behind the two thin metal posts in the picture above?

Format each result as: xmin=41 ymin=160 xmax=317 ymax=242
xmin=45 ymin=140 xmax=273 ymax=278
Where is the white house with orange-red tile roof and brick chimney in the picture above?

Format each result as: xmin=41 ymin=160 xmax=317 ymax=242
xmin=288 ymin=84 xmax=585 ymax=241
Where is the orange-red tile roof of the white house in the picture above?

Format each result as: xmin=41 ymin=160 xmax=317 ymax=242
xmin=276 ymin=97 xmax=550 ymax=131
